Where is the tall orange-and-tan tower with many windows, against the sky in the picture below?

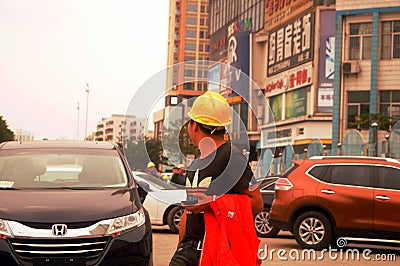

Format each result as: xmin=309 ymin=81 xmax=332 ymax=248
xmin=153 ymin=0 xmax=210 ymax=140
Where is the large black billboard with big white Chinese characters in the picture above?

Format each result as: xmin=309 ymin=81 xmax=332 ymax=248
xmin=267 ymin=12 xmax=314 ymax=76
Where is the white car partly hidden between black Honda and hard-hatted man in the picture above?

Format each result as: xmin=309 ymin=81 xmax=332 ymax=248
xmin=132 ymin=171 xmax=186 ymax=233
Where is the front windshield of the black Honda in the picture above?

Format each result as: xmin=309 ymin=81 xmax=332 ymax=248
xmin=0 ymin=149 xmax=128 ymax=189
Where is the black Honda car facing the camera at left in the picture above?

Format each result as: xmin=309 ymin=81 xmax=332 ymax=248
xmin=0 ymin=141 xmax=152 ymax=266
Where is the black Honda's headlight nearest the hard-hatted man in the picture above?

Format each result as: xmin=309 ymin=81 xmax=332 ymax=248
xmin=106 ymin=209 xmax=146 ymax=236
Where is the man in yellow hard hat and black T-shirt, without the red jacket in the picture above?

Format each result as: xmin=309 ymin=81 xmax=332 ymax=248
xmin=170 ymin=92 xmax=263 ymax=266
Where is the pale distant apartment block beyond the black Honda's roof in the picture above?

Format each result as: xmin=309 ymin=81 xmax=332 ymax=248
xmin=94 ymin=114 xmax=146 ymax=143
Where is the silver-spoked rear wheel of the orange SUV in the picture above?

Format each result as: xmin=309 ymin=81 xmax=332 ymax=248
xmin=293 ymin=211 xmax=333 ymax=250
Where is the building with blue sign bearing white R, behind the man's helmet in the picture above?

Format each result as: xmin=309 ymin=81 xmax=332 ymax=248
xmin=209 ymin=0 xmax=266 ymax=161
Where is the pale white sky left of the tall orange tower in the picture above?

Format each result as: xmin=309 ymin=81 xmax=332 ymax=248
xmin=0 ymin=0 xmax=169 ymax=139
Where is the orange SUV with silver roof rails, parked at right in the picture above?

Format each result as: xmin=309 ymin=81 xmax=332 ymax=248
xmin=270 ymin=156 xmax=400 ymax=249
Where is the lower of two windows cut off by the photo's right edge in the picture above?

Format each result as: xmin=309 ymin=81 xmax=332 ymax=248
xmin=379 ymin=90 xmax=400 ymax=123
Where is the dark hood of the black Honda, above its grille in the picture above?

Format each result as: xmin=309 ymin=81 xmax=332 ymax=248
xmin=0 ymin=189 xmax=137 ymax=223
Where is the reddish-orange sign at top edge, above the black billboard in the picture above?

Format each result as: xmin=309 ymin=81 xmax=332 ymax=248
xmin=265 ymin=0 xmax=313 ymax=30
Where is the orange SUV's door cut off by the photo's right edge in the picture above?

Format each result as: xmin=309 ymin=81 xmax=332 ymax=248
xmin=374 ymin=166 xmax=400 ymax=234
